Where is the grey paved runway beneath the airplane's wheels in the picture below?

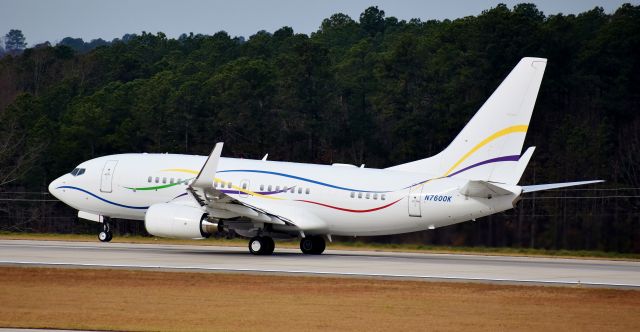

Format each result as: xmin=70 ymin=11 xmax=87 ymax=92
xmin=0 ymin=240 xmax=640 ymax=288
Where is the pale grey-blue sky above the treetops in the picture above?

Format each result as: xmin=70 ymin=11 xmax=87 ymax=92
xmin=0 ymin=0 xmax=640 ymax=46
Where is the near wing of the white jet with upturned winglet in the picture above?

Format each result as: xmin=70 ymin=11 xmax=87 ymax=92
xmin=187 ymin=143 xmax=326 ymax=231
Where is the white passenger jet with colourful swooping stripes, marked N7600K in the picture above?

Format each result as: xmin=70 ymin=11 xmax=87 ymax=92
xmin=49 ymin=58 xmax=603 ymax=255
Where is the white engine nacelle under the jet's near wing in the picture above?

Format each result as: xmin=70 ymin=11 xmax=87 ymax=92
xmin=144 ymin=203 xmax=217 ymax=239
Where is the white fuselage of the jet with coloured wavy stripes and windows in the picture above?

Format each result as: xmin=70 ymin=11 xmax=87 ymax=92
xmin=49 ymin=153 xmax=519 ymax=236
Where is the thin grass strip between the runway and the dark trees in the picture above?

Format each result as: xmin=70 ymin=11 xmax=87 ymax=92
xmin=0 ymin=232 xmax=640 ymax=260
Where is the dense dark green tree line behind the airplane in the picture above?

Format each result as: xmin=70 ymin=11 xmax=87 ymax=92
xmin=0 ymin=4 xmax=640 ymax=252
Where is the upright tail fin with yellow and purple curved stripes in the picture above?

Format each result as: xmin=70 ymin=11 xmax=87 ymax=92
xmin=389 ymin=58 xmax=547 ymax=184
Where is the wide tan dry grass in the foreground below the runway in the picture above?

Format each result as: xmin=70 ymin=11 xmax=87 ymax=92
xmin=0 ymin=267 xmax=640 ymax=331
